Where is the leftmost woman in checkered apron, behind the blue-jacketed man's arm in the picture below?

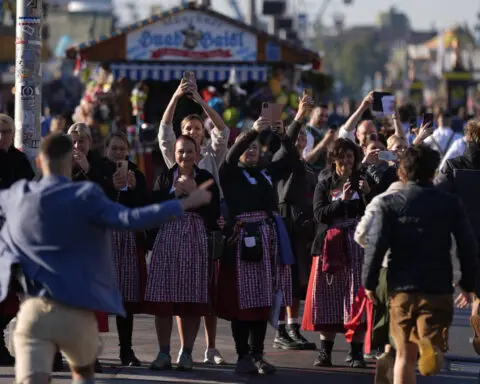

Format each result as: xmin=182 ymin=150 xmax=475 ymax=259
xmin=95 ymin=131 xmax=148 ymax=366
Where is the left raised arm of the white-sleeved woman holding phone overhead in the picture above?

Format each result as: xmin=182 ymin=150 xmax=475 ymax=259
xmin=158 ymin=81 xmax=189 ymax=168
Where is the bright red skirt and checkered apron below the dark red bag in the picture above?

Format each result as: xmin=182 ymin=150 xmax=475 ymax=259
xmin=302 ymin=219 xmax=365 ymax=332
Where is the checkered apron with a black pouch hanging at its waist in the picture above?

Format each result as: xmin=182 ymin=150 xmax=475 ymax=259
xmin=236 ymin=212 xmax=292 ymax=309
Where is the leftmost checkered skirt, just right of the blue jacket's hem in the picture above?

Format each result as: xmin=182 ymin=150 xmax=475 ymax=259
xmin=111 ymin=230 xmax=147 ymax=313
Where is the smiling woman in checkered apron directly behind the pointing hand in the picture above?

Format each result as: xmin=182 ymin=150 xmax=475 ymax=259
xmin=145 ymin=136 xmax=220 ymax=370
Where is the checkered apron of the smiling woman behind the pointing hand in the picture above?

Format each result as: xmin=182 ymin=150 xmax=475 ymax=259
xmin=145 ymin=212 xmax=208 ymax=304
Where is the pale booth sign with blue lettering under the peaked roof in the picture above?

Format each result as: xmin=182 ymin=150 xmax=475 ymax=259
xmin=127 ymin=10 xmax=257 ymax=62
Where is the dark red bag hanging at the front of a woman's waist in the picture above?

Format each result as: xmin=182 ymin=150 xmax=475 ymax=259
xmin=322 ymin=228 xmax=347 ymax=274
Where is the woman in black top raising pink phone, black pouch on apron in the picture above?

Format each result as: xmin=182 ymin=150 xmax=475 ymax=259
xmin=217 ymin=118 xmax=292 ymax=374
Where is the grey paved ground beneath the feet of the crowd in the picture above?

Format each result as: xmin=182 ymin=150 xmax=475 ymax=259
xmin=0 ymin=311 xmax=480 ymax=384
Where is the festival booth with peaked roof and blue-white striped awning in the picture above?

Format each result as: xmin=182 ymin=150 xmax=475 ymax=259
xmin=63 ymin=3 xmax=319 ymax=122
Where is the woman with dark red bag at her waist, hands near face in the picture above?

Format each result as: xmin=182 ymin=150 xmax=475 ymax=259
xmin=302 ymin=138 xmax=370 ymax=368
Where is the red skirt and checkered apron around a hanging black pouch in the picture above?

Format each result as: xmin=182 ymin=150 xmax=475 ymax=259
xmin=217 ymin=212 xmax=292 ymax=321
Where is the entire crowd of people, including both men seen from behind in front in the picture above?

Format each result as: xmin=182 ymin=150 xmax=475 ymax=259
xmin=0 ymin=73 xmax=480 ymax=384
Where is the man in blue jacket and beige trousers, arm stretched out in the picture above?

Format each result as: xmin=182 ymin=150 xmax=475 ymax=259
xmin=0 ymin=134 xmax=211 ymax=384
